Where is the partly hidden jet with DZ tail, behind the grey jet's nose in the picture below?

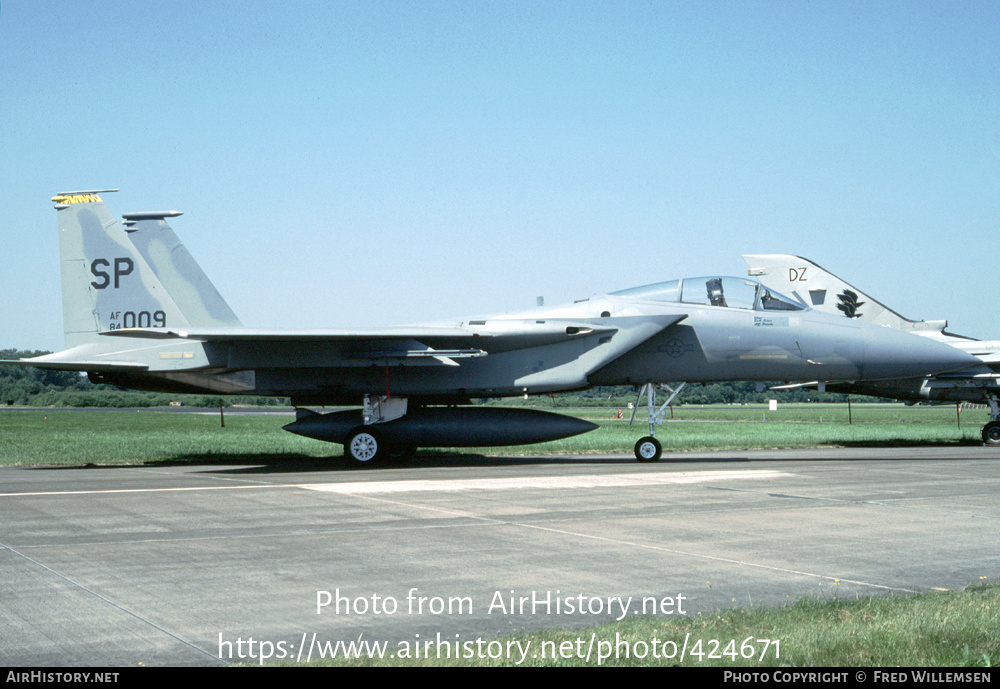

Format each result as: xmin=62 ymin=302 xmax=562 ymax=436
xmin=743 ymin=254 xmax=1000 ymax=445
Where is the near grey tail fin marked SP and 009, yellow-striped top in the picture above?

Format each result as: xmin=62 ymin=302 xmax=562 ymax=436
xmin=52 ymin=189 xmax=190 ymax=349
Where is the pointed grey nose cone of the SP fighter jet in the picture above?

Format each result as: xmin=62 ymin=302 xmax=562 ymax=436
xmin=863 ymin=324 xmax=982 ymax=380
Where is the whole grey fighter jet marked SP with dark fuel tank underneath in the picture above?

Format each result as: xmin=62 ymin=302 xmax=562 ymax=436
xmin=0 ymin=190 xmax=976 ymax=464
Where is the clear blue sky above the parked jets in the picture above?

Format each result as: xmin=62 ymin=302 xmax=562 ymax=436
xmin=0 ymin=0 xmax=1000 ymax=349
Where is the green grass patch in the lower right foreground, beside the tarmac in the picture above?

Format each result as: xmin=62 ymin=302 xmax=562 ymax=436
xmin=270 ymin=584 xmax=1000 ymax=668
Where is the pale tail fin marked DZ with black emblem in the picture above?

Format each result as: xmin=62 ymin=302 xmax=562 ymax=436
xmin=743 ymin=254 xmax=948 ymax=332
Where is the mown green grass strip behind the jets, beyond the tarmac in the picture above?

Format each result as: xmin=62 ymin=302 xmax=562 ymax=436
xmin=0 ymin=404 xmax=988 ymax=466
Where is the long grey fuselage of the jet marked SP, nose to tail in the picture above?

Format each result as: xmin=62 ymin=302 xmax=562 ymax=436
xmin=90 ymin=297 xmax=980 ymax=404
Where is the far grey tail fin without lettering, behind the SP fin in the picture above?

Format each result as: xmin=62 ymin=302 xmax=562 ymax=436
xmin=122 ymin=211 xmax=243 ymax=327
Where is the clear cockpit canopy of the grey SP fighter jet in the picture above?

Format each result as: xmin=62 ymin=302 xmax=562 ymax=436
xmin=611 ymin=277 xmax=806 ymax=311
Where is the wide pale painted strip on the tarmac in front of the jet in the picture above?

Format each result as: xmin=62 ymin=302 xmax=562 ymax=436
xmin=298 ymin=469 xmax=794 ymax=495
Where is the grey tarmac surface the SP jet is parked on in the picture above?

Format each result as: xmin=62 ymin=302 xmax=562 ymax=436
xmin=0 ymin=447 xmax=1000 ymax=667
